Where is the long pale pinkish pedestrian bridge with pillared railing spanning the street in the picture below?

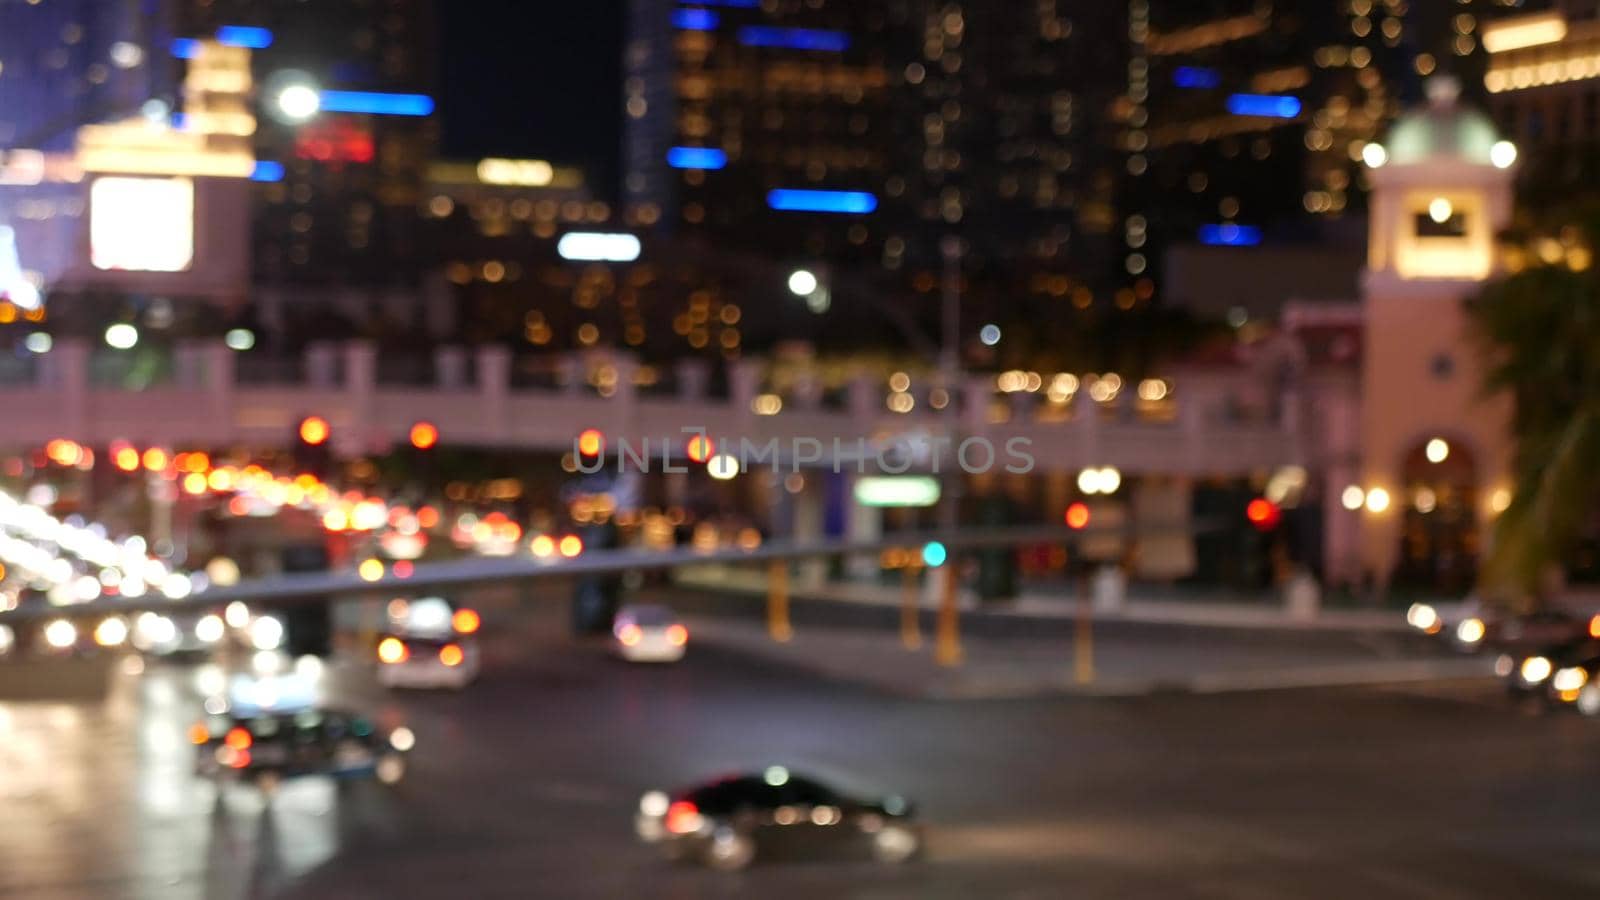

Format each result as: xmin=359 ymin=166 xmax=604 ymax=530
xmin=0 ymin=338 xmax=1306 ymax=477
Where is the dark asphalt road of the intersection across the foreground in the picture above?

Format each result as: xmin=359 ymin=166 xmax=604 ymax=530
xmin=0 ymin=595 xmax=1600 ymax=900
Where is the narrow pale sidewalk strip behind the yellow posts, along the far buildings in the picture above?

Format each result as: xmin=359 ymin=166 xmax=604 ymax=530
xmin=677 ymin=567 xmax=1411 ymax=634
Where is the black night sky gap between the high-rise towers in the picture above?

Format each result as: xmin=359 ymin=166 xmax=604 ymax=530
xmin=435 ymin=0 xmax=624 ymax=197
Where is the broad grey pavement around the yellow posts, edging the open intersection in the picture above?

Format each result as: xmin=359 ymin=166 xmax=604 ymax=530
xmin=674 ymin=569 xmax=1493 ymax=700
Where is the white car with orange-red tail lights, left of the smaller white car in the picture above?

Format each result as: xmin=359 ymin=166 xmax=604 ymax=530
xmin=378 ymin=597 xmax=482 ymax=690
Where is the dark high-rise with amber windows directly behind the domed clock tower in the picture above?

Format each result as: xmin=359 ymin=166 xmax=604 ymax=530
xmin=1122 ymin=0 xmax=1538 ymax=305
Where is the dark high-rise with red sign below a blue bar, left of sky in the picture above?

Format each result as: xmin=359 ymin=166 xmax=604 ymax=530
xmin=174 ymin=0 xmax=437 ymax=285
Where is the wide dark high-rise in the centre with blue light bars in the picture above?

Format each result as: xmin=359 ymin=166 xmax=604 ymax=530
xmin=622 ymin=0 xmax=1123 ymax=357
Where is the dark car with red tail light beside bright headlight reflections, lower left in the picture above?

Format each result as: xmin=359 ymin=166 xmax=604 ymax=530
xmin=189 ymin=708 xmax=416 ymax=790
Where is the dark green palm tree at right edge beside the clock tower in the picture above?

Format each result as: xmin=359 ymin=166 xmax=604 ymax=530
xmin=1469 ymin=208 xmax=1600 ymax=605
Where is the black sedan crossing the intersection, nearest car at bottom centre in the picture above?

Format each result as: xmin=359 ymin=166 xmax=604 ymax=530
xmin=634 ymin=765 xmax=922 ymax=871
